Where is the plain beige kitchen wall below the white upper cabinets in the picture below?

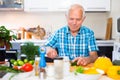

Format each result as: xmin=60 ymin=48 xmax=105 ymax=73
xmin=0 ymin=0 xmax=120 ymax=38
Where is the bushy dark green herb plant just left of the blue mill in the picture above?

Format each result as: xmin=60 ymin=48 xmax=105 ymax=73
xmin=21 ymin=42 xmax=39 ymax=60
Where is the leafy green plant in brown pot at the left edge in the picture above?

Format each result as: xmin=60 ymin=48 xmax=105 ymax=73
xmin=0 ymin=26 xmax=17 ymax=50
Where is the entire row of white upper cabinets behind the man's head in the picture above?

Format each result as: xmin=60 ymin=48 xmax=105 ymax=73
xmin=24 ymin=0 xmax=110 ymax=11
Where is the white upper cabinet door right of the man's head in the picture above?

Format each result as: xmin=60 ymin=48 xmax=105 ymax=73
xmin=84 ymin=0 xmax=110 ymax=11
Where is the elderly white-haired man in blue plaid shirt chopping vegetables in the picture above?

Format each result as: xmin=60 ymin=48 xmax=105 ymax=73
xmin=45 ymin=4 xmax=98 ymax=65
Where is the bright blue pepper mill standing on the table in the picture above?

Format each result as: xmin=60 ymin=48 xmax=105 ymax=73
xmin=38 ymin=46 xmax=46 ymax=80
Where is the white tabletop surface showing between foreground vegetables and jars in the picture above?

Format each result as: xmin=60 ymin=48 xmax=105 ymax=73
xmin=0 ymin=63 xmax=113 ymax=80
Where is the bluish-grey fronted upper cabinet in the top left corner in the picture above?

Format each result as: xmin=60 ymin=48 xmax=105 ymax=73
xmin=0 ymin=0 xmax=24 ymax=11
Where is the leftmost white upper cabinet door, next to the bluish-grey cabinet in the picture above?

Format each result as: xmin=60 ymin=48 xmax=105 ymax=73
xmin=24 ymin=0 xmax=51 ymax=11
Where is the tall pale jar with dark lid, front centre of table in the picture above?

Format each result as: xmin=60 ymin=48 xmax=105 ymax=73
xmin=54 ymin=57 xmax=63 ymax=79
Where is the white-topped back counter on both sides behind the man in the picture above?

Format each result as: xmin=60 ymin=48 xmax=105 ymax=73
xmin=11 ymin=39 xmax=114 ymax=60
